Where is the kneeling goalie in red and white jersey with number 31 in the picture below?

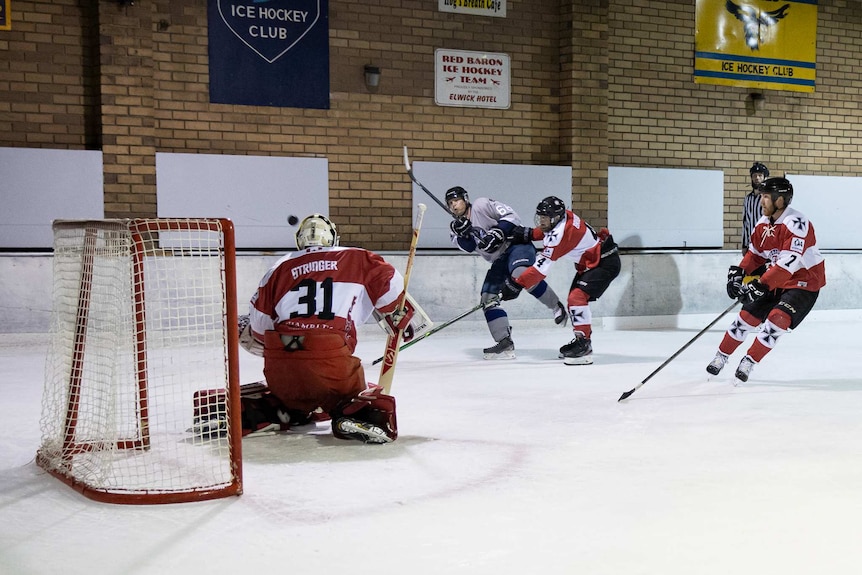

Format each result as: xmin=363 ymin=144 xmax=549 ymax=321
xmin=241 ymin=214 xmax=412 ymax=443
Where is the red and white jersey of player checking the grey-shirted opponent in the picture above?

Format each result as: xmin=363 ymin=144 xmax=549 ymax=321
xmin=516 ymin=210 xmax=602 ymax=288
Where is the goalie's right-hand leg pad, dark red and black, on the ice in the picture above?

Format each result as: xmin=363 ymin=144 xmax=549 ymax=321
xmin=332 ymin=389 xmax=398 ymax=443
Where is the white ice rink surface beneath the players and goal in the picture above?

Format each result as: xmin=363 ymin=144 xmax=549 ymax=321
xmin=0 ymin=311 xmax=862 ymax=575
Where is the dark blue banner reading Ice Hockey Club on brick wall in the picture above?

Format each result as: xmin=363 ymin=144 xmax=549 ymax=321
xmin=208 ymin=0 xmax=329 ymax=109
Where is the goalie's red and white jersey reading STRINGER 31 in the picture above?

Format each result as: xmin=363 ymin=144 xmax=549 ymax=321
xmin=249 ymin=247 xmax=404 ymax=352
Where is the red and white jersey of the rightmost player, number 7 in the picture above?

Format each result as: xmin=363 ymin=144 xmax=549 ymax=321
xmin=739 ymin=208 xmax=826 ymax=291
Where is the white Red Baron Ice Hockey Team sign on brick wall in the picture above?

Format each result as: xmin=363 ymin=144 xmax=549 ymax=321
xmin=434 ymin=48 xmax=512 ymax=109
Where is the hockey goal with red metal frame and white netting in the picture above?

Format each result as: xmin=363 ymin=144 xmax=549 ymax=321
xmin=36 ymin=219 xmax=242 ymax=504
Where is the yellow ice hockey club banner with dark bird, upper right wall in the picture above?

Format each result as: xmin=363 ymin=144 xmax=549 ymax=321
xmin=694 ymin=0 xmax=817 ymax=92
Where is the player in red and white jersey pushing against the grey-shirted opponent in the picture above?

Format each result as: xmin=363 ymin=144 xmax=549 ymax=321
xmin=504 ymin=196 xmax=621 ymax=365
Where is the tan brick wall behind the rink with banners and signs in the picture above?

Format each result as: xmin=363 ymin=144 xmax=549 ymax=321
xmin=0 ymin=0 xmax=862 ymax=250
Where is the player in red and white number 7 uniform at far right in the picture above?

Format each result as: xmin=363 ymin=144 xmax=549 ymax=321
xmin=706 ymin=178 xmax=826 ymax=383
